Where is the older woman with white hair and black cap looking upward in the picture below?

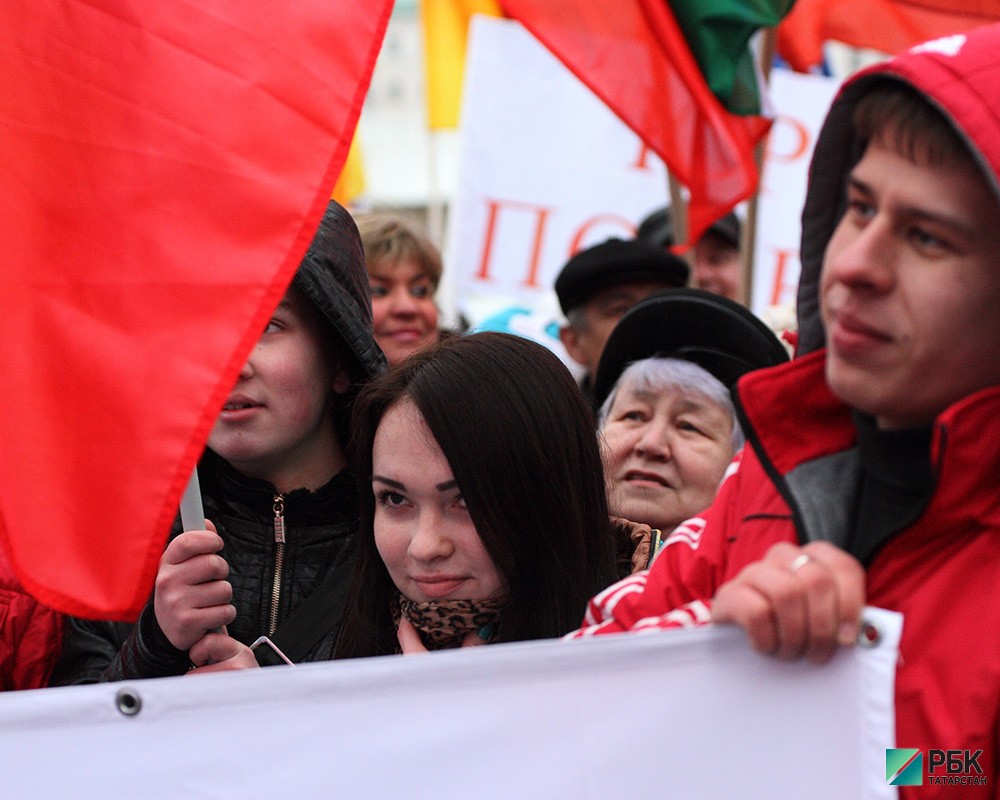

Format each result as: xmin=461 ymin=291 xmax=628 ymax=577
xmin=594 ymin=289 xmax=788 ymax=573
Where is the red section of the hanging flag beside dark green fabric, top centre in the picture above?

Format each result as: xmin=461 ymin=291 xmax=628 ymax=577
xmin=502 ymin=0 xmax=770 ymax=241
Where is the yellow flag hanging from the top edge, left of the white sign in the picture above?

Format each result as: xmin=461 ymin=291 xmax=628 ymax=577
xmin=420 ymin=0 xmax=503 ymax=129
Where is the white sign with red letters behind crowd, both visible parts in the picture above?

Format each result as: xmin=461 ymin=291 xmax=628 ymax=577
xmin=445 ymin=16 xmax=838 ymax=360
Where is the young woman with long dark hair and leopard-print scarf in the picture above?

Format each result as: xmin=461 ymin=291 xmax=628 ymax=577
xmin=336 ymin=333 xmax=615 ymax=657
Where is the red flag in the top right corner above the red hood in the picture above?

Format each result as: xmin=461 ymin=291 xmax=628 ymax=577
xmin=778 ymin=0 xmax=1000 ymax=72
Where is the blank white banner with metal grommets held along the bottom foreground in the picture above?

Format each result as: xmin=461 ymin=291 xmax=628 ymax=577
xmin=0 ymin=610 xmax=901 ymax=800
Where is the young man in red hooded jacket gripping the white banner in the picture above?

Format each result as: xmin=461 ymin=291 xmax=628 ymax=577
xmin=575 ymin=25 xmax=1000 ymax=798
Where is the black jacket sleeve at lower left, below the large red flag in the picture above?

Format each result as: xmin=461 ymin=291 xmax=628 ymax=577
xmin=49 ymin=601 xmax=190 ymax=686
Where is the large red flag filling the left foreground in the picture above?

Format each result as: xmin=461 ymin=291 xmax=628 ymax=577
xmin=0 ymin=0 xmax=392 ymax=619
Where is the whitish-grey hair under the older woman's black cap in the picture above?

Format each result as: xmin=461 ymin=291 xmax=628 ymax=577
xmin=597 ymin=356 xmax=744 ymax=453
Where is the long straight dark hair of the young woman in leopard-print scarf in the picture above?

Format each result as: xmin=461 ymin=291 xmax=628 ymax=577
xmin=336 ymin=333 xmax=615 ymax=658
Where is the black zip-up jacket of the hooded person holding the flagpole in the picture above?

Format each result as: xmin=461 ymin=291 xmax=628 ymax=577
xmin=52 ymin=451 xmax=358 ymax=686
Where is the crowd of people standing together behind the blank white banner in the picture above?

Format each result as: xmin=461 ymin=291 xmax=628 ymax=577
xmin=0 ymin=21 xmax=1000 ymax=797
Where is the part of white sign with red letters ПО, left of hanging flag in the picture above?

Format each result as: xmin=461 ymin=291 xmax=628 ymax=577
xmin=445 ymin=16 xmax=668 ymax=368
